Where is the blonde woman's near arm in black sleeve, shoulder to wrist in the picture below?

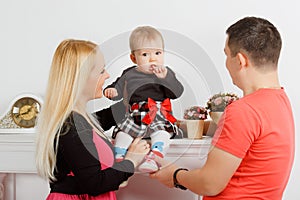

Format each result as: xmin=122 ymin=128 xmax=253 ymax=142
xmin=58 ymin=116 xmax=134 ymax=195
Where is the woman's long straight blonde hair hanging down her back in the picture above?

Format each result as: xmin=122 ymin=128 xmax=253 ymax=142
xmin=36 ymin=39 xmax=97 ymax=181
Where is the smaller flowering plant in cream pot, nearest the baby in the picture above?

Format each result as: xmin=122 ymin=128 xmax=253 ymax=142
xmin=183 ymin=106 xmax=207 ymax=139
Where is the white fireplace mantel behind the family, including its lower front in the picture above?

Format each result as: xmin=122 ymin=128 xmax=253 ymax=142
xmin=0 ymin=129 xmax=211 ymax=200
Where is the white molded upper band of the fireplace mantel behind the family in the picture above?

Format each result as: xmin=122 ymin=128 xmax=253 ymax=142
xmin=0 ymin=129 xmax=211 ymax=173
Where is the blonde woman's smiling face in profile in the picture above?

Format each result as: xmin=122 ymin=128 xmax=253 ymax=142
xmin=86 ymin=50 xmax=109 ymax=99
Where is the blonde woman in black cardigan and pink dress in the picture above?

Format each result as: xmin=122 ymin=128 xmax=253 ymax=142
xmin=36 ymin=40 xmax=150 ymax=200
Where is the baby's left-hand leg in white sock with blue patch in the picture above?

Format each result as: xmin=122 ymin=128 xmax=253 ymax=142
xmin=114 ymin=131 xmax=133 ymax=161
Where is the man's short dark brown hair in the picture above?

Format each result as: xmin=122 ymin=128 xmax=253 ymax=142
xmin=226 ymin=17 xmax=282 ymax=66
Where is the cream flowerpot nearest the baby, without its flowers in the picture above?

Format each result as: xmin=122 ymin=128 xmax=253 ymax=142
xmin=185 ymin=120 xmax=204 ymax=139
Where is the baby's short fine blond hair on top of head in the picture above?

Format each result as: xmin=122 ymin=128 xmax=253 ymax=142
xmin=129 ymin=26 xmax=164 ymax=53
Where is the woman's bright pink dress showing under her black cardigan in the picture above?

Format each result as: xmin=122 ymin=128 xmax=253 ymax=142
xmin=47 ymin=130 xmax=117 ymax=200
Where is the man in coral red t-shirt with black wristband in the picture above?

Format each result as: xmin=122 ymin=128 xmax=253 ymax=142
xmin=150 ymin=17 xmax=295 ymax=200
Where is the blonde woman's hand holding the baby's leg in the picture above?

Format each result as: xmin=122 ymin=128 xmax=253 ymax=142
xmin=125 ymin=138 xmax=150 ymax=167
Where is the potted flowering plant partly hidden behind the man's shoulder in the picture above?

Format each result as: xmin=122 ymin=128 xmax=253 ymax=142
xmin=206 ymin=92 xmax=239 ymax=124
